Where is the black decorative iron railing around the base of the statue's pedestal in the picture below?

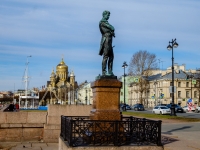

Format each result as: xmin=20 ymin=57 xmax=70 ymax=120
xmin=60 ymin=116 xmax=162 ymax=147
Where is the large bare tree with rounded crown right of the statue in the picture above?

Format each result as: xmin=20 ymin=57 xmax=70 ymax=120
xmin=128 ymin=50 xmax=157 ymax=103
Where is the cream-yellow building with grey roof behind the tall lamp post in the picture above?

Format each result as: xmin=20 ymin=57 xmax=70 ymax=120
xmin=127 ymin=64 xmax=200 ymax=107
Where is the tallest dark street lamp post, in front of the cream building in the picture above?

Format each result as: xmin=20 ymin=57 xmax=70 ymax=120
xmin=167 ymin=39 xmax=178 ymax=116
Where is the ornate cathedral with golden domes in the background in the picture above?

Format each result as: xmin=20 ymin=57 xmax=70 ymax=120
xmin=41 ymin=58 xmax=78 ymax=105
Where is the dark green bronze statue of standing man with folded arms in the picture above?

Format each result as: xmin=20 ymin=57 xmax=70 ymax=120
xmin=99 ymin=10 xmax=115 ymax=76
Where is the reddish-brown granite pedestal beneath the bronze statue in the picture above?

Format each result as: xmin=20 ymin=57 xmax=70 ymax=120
xmin=90 ymin=78 xmax=122 ymax=121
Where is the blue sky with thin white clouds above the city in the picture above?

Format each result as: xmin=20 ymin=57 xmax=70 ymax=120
xmin=0 ymin=0 xmax=200 ymax=91
